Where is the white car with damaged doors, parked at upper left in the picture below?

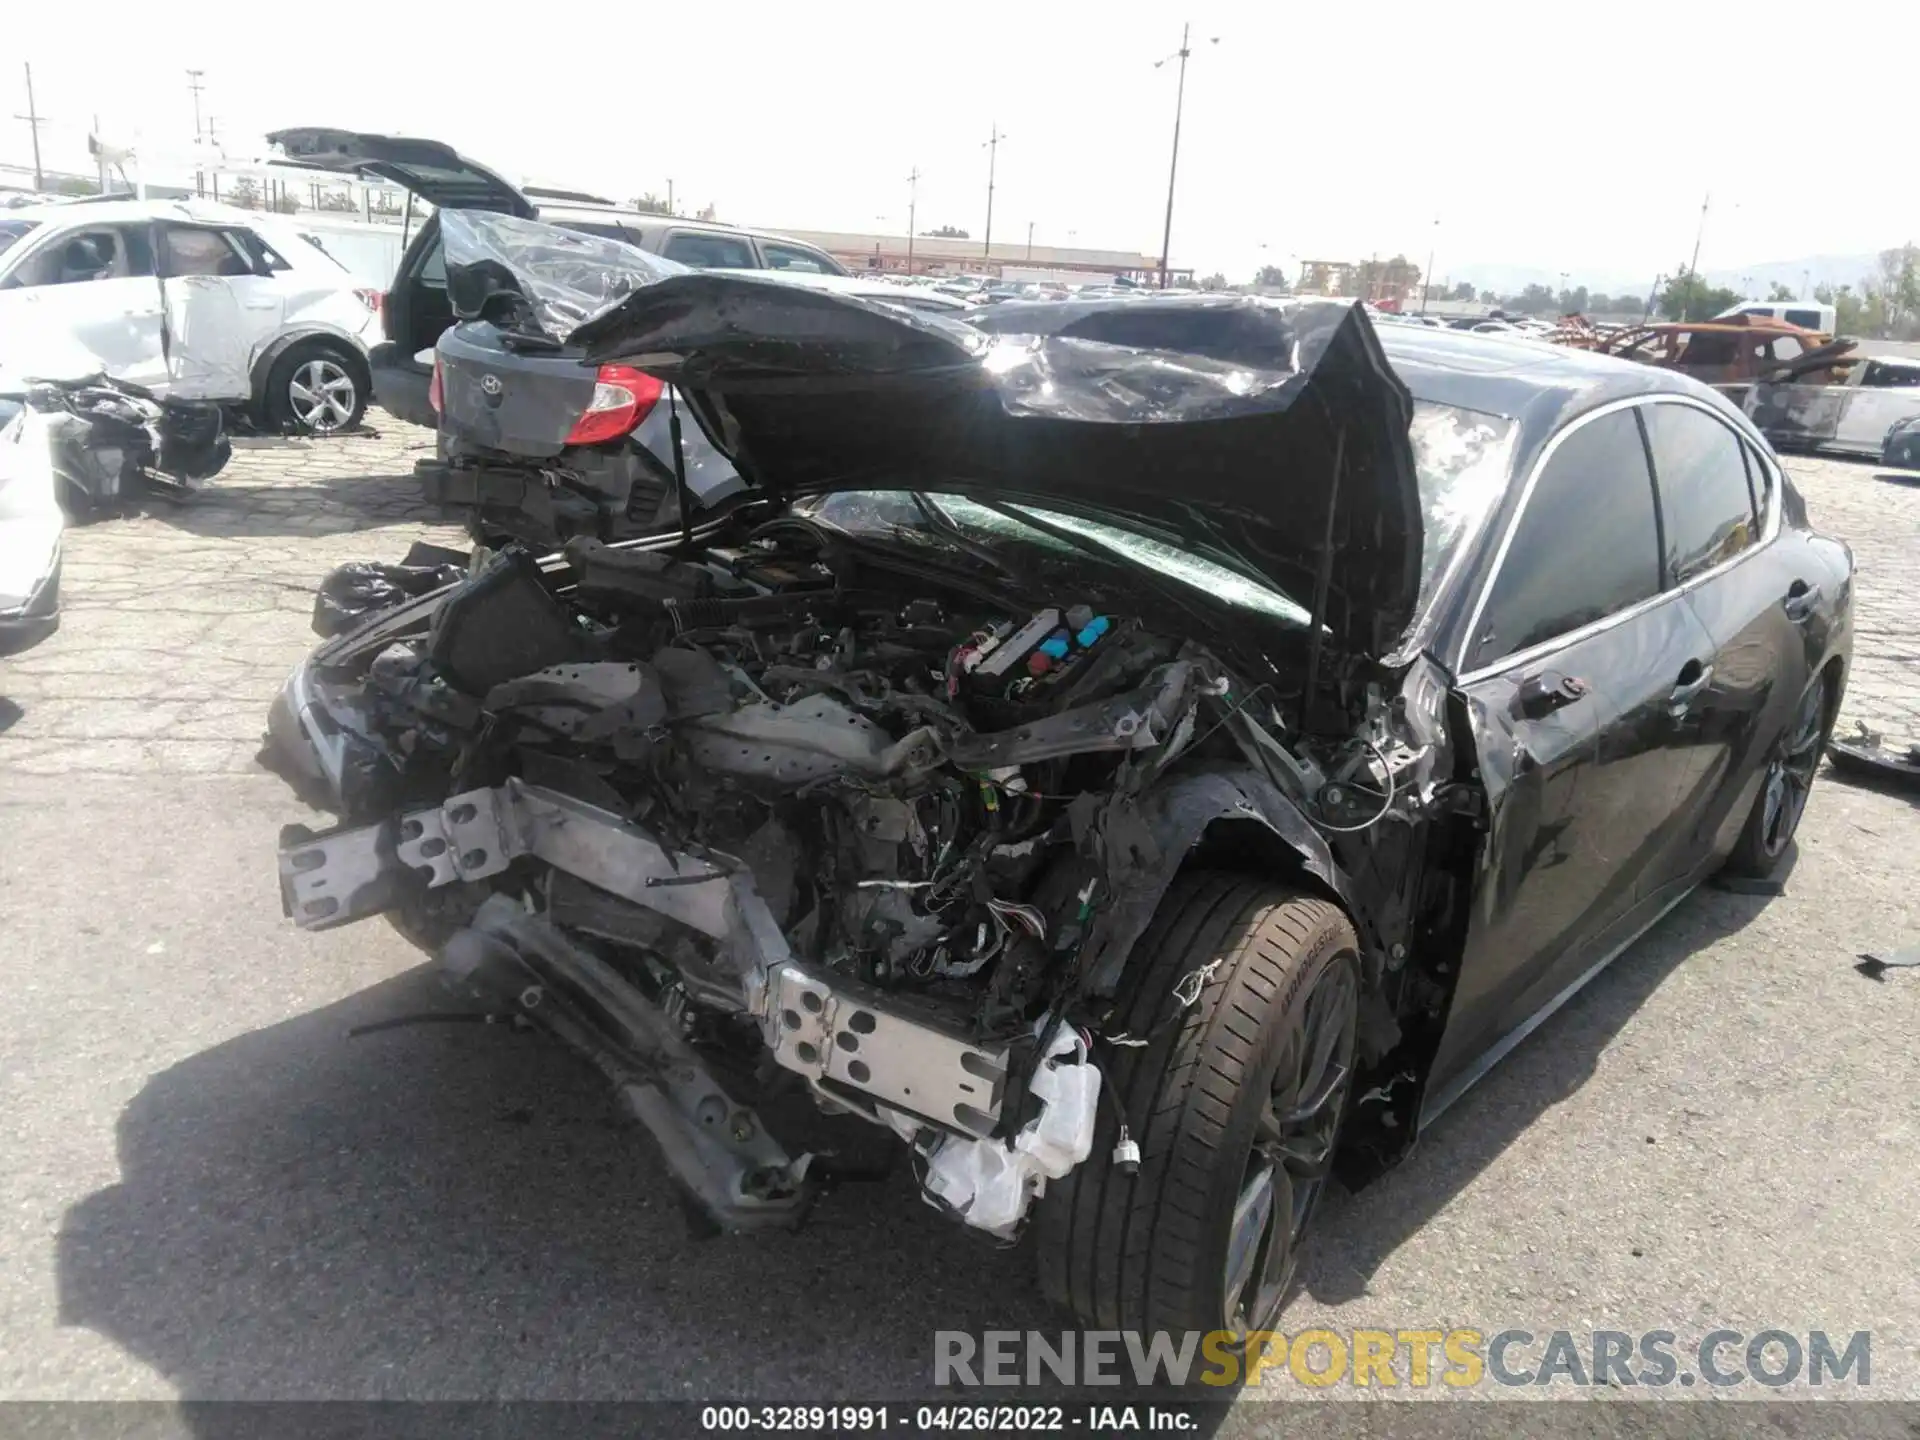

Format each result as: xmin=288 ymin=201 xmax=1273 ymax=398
xmin=0 ymin=200 xmax=378 ymax=432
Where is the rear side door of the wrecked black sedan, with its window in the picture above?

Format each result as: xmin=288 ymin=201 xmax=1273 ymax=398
xmin=1645 ymin=399 xmax=1822 ymax=887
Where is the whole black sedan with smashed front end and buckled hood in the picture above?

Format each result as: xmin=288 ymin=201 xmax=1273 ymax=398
xmin=271 ymin=247 xmax=1853 ymax=1331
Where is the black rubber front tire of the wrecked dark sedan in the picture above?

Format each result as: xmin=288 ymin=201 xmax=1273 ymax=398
xmin=1035 ymin=872 xmax=1359 ymax=1332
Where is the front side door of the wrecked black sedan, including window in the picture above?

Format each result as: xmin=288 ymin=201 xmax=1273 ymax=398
xmin=1427 ymin=407 xmax=1713 ymax=1114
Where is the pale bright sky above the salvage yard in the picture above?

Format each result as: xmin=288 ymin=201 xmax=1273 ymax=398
xmin=15 ymin=0 xmax=1920 ymax=282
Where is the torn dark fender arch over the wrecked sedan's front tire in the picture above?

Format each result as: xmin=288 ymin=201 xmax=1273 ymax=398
xmin=1083 ymin=766 xmax=1354 ymax=995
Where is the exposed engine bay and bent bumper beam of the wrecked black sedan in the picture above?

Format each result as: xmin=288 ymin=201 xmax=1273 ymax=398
xmin=271 ymin=516 xmax=1427 ymax=1235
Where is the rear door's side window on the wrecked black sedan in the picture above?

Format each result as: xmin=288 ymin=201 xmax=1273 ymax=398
xmin=1642 ymin=405 xmax=1757 ymax=586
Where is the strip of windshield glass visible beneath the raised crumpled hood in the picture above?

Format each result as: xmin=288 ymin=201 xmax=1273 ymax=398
xmin=806 ymin=490 xmax=1311 ymax=626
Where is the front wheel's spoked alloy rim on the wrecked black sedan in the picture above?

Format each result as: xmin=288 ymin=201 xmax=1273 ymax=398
xmin=1225 ymin=954 xmax=1359 ymax=1334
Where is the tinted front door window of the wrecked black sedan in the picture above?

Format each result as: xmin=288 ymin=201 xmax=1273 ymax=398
xmin=1467 ymin=411 xmax=1666 ymax=670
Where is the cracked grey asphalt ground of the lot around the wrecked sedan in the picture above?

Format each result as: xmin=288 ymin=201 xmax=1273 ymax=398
xmin=0 ymin=415 xmax=1920 ymax=1400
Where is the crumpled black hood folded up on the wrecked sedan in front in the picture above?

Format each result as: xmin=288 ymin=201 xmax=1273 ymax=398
xmin=449 ymin=217 xmax=1421 ymax=655
